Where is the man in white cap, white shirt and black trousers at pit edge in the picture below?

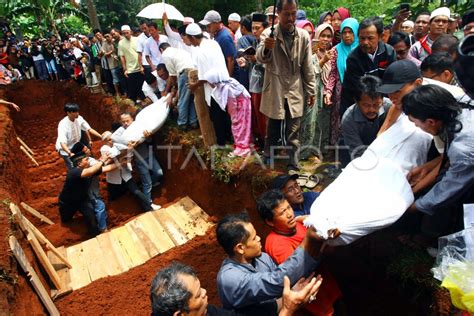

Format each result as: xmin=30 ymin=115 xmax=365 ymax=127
xmin=186 ymin=23 xmax=232 ymax=146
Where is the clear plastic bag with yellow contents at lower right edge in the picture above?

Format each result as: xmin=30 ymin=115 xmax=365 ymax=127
xmin=431 ymin=227 xmax=474 ymax=313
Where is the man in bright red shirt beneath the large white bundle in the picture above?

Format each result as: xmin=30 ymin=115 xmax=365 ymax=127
xmin=257 ymin=190 xmax=342 ymax=315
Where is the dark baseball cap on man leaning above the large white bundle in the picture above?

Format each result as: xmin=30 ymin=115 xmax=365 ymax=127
xmin=377 ymin=59 xmax=421 ymax=94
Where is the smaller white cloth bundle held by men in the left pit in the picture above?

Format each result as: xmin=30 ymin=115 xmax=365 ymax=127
xmin=112 ymin=94 xmax=171 ymax=145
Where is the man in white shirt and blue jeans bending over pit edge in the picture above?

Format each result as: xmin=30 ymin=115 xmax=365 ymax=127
xmin=160 ymin=43 xmax=197 ymax=130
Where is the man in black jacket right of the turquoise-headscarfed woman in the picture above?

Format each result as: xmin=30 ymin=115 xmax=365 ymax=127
xmin=340 ymin=17 xmax=397 ymax=117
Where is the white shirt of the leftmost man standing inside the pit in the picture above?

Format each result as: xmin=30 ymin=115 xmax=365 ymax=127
xmin=56 ymin=115 xmax=91 ymax=156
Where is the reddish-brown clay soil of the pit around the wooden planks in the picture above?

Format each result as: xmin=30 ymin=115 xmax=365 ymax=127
xmin=0 ymin=81 xmax=268 ymax=315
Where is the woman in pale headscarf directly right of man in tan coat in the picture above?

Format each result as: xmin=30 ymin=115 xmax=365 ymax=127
xmin=300 ymin=23 xmax=334 ymax=159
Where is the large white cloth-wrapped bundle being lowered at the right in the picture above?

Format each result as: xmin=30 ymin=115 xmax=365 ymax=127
xmin=304 ymin=114 xmax=432 ymax=246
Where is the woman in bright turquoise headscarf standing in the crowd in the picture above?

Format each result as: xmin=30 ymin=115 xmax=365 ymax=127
xmin=324 ymin=18 xmax=359 ymax=145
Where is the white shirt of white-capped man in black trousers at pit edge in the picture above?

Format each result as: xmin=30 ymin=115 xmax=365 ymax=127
xmin=193 ymin=38 xmax=229 ymax=106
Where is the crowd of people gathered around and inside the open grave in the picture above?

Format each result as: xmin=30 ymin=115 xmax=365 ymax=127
xmin=0 ymin=0 xmax=474 ymax=315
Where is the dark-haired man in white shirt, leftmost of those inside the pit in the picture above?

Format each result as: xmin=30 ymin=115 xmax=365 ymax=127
xmin=56 ymin=103 xmax=102 ymax=170
